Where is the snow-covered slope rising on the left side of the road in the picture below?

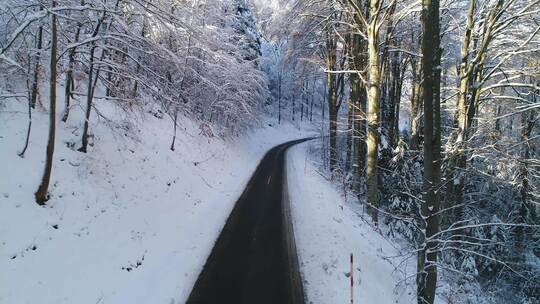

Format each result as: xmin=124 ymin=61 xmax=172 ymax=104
xmin=0 ymin=98 xmax=309 ymax=304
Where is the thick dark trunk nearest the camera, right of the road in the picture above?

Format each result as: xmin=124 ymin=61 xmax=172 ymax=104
xmin=417 ymin=0 xmax=441 ymax=304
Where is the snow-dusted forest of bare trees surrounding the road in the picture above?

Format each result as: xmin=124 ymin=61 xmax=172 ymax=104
xmin=0 ymin=0 xmax=540 ymax=304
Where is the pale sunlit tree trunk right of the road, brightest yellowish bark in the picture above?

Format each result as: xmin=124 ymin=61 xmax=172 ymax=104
xmin=366 ymin=0 xmax=381 ymax=225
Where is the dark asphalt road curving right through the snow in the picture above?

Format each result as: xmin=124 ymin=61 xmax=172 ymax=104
xmin=187 ymin=138 xmax=309 ymax=304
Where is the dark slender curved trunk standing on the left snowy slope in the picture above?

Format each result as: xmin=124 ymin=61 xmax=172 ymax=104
xmin=35 ymin=0 xmax=57 ymax=205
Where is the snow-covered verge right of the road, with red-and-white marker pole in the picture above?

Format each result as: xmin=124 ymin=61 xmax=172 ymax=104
xmin=287 ymin=141 xmax=416 ymax=304
